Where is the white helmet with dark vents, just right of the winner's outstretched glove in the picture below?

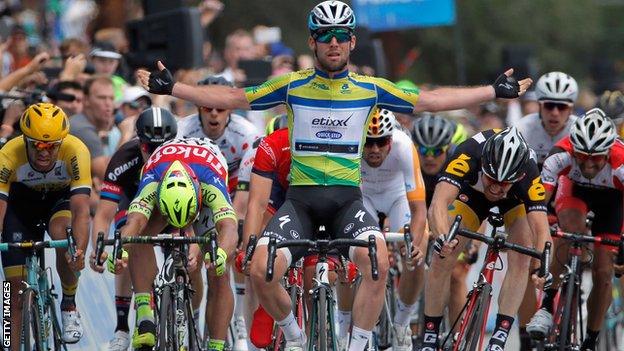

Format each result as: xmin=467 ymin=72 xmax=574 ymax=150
xmin=535 ymin=72 xmax=578 ymax=104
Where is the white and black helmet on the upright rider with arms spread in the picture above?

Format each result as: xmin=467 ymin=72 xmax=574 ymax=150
xmin=308 ymin=0 xmax=355 ymax=32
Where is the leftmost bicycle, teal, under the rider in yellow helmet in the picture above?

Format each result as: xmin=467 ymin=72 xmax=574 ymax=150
xmin=0 ymin=227 xmax=78 ymax=351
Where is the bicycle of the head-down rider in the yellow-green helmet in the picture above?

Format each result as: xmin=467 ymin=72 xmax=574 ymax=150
xmin=96 ymin=230 xmax=218 ymax=351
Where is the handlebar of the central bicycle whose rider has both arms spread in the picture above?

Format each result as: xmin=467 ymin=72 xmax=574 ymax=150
xmin=265 ymin=235 xmax=379 ymax=282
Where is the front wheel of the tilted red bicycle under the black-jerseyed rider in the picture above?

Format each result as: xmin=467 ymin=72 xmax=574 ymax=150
xmin=453 ymin=284 xmax=492 ymax=351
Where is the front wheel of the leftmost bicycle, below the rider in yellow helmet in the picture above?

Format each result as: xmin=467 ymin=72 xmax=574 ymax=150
xmin=21 ymin=288 xmax=47 ymax=351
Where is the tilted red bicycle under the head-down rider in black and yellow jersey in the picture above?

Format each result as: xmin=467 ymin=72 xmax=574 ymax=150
xmin=442 ymin=212 xmax=551 ymax=351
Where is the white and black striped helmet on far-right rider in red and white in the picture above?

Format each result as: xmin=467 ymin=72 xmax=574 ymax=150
xmin=570 ymin=108 xmax=618 ymax=154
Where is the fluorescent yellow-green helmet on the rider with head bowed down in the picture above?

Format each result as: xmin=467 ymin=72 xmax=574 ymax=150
xmin=158 ymin=161 xmax=201 ymax=228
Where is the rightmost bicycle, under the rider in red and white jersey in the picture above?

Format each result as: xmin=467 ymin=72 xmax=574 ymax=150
xmin=532 ymin=228 xmax=624 ymax=351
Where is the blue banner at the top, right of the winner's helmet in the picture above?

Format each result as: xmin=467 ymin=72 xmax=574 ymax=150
xmin=353 ymin=0 xmax=455 ymax=32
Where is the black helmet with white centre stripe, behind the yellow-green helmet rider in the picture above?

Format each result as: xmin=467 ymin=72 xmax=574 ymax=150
xmin=136 ymin=107 xmax=178 ymax=146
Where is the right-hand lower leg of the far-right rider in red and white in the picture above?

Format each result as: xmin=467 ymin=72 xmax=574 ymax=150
xmin=581 ymin=245 xmax=613 ymax=350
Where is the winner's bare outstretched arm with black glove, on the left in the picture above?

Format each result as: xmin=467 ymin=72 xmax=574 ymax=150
xmin=137 ymin=61 xmax=250 ymax=110
